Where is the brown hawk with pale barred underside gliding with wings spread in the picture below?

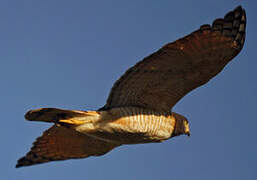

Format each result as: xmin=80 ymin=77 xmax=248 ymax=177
xmin=16 ymin=6 xmax=246 ymax=167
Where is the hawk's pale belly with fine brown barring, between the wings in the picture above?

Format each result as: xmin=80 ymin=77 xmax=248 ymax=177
xmin=95 ymin=107 xmax=175 ymax=144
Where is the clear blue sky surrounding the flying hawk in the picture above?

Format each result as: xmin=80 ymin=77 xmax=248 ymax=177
xmin=0 ymin=0 xmax=257 ymax=180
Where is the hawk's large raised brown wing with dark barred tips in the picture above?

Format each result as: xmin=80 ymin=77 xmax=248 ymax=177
xmin=103 ymin=6 xmax=246 ymax=111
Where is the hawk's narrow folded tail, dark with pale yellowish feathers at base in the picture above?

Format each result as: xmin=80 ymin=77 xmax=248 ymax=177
xmin=25 ymin=108 xmax=100 ymax=125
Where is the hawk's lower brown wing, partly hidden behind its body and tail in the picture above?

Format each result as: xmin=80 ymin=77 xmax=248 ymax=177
xmin=16 ymin=125 xmax=119 ymax=167
